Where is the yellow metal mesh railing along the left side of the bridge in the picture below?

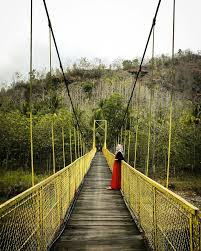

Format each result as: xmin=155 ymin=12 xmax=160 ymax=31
xmin=0 ymin=148 xmax=96 ymax=251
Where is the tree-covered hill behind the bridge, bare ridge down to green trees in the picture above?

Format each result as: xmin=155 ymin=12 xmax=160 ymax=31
xmin=0 ymin=50 xmax=201 ymax=199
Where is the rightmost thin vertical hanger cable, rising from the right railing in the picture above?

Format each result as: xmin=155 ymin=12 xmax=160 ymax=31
xmin=166 ymin=0 xmax=176 ymax=188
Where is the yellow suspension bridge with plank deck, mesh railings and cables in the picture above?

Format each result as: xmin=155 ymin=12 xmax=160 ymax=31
xmin=0 ymin=0 xmax=201 ymax=251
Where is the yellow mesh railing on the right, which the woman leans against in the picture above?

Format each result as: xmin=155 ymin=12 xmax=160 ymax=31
xmin=103 ymin=149 xmax=201 ymax=251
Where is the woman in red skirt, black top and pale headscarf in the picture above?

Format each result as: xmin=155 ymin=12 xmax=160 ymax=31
xmin=108 ymin=144 xmax=124 ymax=190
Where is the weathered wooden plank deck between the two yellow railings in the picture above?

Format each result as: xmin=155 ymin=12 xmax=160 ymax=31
xmin=51 ymin=153 xmax=146 ymax=251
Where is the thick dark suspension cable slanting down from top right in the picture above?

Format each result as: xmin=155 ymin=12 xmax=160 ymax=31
xmin=117 ymin=0 xmax=161 ymax=139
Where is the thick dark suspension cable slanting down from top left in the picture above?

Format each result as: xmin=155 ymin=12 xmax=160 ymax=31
xmin=43 ymin=0 xmax=84 ymax=141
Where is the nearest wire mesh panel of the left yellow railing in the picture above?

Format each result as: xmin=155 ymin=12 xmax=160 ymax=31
xmin=0 ymin=192 xmax=39 ymax=250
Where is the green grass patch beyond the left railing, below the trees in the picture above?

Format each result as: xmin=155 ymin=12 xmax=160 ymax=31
xmin=0 ymin=170 xmax=47 ymax=203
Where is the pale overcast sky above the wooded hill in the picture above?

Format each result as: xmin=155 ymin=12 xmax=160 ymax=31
xmin=0 ymin=0 xmax=201 ymax=83
